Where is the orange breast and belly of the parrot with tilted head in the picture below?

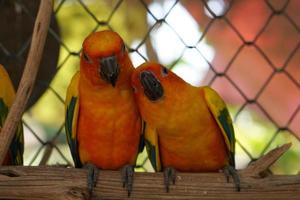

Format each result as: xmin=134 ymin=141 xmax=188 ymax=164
xmin=151 ymin=89 xmax=228 ymax=172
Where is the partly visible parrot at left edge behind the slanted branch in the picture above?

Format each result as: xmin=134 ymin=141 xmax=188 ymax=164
xmin=0 ymin=64 xmax=24 ymax=165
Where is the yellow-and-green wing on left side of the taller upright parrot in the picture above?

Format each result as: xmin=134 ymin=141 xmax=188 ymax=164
xmin=65 ymin=72 xmax=82 ymax=167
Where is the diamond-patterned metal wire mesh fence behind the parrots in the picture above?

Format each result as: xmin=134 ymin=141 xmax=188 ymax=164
xmin=0 ymin=0 xmax=300 ymax=173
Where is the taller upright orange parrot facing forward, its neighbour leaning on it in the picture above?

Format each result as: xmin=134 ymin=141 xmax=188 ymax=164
xmin=65 ymin=30 xmax=144 ymax=196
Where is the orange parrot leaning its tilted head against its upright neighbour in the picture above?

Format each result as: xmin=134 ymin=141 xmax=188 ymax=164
xmin=131 ymin=62 xmax=240 ymax=192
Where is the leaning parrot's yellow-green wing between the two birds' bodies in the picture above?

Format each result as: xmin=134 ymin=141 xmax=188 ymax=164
xmin=145 ymin=124 xmax=161 ymax=171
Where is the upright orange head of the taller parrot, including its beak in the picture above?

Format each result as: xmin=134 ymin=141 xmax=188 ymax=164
xmin=80 ymin=30 xmax=128 ymax=87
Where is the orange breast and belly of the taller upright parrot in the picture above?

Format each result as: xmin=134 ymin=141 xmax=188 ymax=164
xmin=77 ymin=77 xmax=141 ymax=170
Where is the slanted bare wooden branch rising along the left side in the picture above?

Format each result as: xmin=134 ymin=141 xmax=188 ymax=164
xmin=0 ymin=0 xmax=53 ymax=165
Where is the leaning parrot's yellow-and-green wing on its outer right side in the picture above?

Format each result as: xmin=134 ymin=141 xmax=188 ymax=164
xmin=203 ymin=87 xmax=235 ymax=167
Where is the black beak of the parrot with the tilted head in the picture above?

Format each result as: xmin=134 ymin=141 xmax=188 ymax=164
xmin=140 ymin=71 xmax=164 ymax=101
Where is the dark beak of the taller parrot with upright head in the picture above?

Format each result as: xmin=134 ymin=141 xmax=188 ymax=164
xmin=99 ymin=56 xmax=120 ymax=87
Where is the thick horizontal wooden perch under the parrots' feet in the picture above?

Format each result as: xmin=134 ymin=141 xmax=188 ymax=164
xmin=0 ymin=146 xmax=300 ymax=200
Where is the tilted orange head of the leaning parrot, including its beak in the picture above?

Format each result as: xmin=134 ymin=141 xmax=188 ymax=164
xmin=131 ymin=62 xmax=181 ymax=101
